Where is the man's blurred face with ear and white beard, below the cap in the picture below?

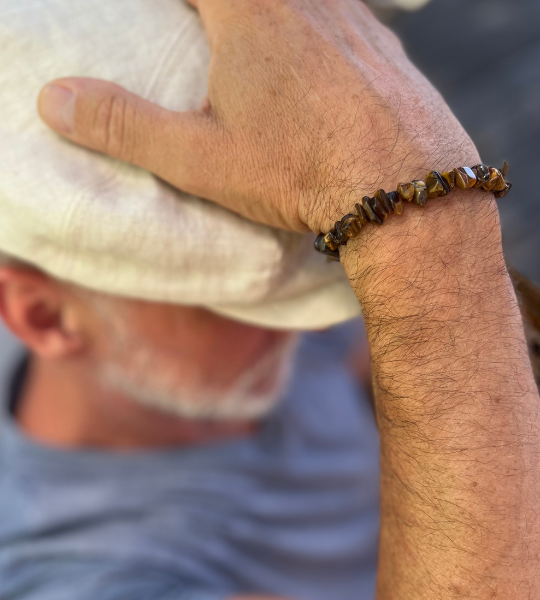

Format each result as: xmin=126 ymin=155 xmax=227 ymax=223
xmin=0 ymin=257 xmax=296 ymax=420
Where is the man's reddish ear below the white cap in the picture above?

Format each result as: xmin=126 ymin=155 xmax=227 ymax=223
xmin=0 ymin=267 xmax=85 ymax=358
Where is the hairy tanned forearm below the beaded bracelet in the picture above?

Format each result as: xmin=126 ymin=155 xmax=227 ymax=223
xmin=344 ymin=192 xmax=540 ymax=600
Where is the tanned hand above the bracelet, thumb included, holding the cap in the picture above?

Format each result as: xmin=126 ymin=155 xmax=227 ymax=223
xmin=39 ymin=0 xmax=477 ymax=232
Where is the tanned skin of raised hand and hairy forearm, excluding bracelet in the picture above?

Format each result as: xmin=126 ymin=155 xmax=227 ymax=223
xmin=40 ymin=0 xmax=540 ymax=600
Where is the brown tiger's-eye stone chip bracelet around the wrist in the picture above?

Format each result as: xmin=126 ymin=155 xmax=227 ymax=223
xmin=315 ymin=162 xmax=512 ymax=260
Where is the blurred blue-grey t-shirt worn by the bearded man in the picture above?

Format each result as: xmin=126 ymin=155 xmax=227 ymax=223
xmin=0 ymin=325 xmax=379 ymax=600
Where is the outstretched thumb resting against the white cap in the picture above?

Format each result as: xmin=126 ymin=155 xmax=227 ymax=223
xmin=38 ymin=78 xmax=219 ymax=195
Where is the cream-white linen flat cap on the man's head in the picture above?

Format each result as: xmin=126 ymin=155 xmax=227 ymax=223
xmin=0 ymin=0 xmax=360 ymax=329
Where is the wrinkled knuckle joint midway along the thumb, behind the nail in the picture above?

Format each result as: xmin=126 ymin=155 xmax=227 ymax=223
xmin=90 ymin=94 xmax=134 ymax=161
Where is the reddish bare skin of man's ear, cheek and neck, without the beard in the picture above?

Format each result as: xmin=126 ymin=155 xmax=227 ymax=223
xmin=0 ymin=267 xmax=295 ymax=449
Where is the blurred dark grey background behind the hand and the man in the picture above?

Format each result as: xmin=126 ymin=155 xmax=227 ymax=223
xmin=0 ymin=0 xmax=540 ymax=366
